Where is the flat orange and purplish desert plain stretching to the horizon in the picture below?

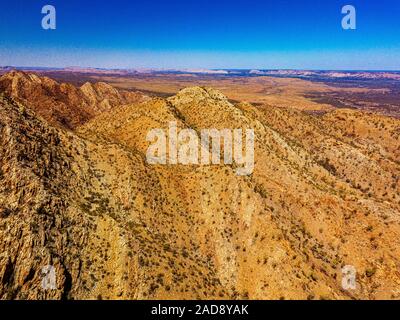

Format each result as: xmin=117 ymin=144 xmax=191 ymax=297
xmin=15 ymin=68 xmax=400 ymax=118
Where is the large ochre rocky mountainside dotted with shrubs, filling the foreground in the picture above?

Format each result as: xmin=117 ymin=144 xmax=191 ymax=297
xmin=0 ymin=79 xmax=400 ymax=299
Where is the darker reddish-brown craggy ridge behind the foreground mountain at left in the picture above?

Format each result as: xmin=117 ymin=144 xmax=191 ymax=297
xmin=0 ymin=71 xmax=146 ymax=129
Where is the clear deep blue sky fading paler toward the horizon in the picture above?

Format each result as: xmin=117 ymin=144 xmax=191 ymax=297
xmin=0 ymin=0 xmax=400 ymax=70
